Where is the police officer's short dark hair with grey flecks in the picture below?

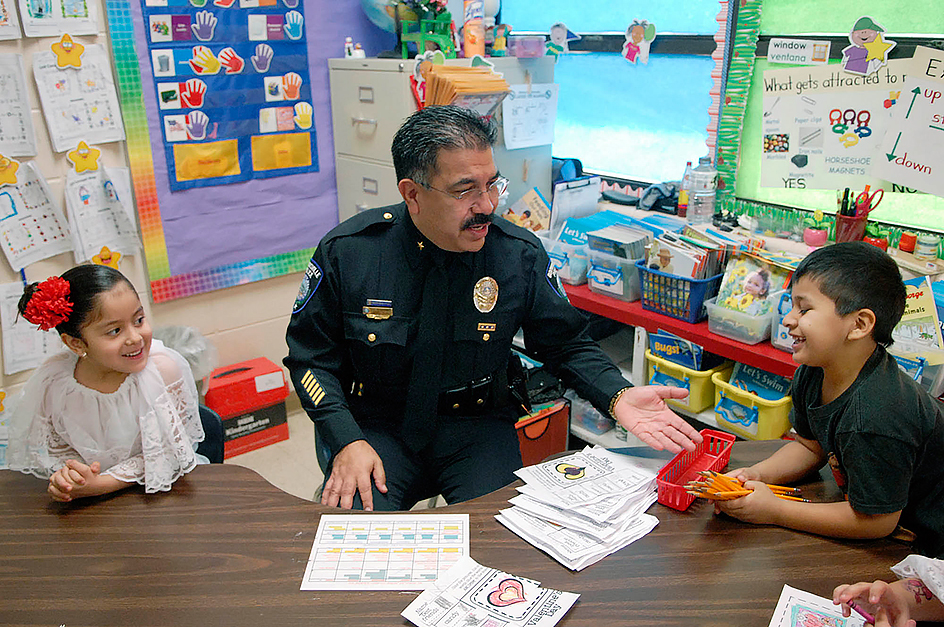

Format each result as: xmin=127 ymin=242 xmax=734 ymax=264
xmin=391 ymin=105 xmax=497 ymax=185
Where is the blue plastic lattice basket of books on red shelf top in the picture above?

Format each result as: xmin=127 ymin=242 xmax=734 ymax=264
xmin=636 ymin=259 xmax=724 ymax=323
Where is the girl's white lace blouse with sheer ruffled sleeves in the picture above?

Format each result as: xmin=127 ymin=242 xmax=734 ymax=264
xmin=7 ymin=340 xmax=204 ymax=492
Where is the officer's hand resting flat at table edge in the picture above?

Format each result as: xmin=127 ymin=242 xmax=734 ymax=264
xmin=321 ymin=440 xmax=387 ymax=512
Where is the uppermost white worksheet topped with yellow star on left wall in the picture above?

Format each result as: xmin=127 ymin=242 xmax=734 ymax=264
xmin=33 ymin=44 xmax=125 ymax=152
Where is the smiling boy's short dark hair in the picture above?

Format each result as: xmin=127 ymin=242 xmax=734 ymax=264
xmin=791 ymin=242 xmax=906 ymax=346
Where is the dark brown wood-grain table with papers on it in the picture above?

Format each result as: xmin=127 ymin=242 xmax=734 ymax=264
xmin=0 ymin=442 xmax=909 ymax=627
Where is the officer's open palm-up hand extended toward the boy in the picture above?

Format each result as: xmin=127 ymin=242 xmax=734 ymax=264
xmin=613 ymin=385 xmax=702 ymax=453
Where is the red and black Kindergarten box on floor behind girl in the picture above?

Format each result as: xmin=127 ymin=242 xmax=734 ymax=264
xmin=204 ymin=357 xmax=288 ymax=458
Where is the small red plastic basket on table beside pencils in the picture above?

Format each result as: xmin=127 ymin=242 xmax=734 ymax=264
xmin=656 ymin=429 xmax=737 ymax=511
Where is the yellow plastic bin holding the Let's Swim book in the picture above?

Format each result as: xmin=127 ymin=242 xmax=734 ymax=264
xmin=711 ymin=372 xmax=793 ymax=440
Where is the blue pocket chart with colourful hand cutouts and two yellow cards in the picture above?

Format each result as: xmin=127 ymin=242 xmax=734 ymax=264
xmin=141 ymin=0 xmax=318 ymax=191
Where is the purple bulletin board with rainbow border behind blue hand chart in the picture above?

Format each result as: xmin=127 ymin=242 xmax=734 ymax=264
xmin=106 ymin=0 xmax=393 ymax=302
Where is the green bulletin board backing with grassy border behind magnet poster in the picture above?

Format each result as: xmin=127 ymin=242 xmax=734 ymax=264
xmin=718 ymin=0 xmax=944 ymax=230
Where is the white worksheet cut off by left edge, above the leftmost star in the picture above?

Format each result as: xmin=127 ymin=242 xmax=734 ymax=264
xmin=0 ymin=55 xmax=36 ymax=157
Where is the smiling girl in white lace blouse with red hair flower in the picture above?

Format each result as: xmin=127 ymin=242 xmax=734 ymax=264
xmin=7 ymin=265 xmax=204 ymax=502
